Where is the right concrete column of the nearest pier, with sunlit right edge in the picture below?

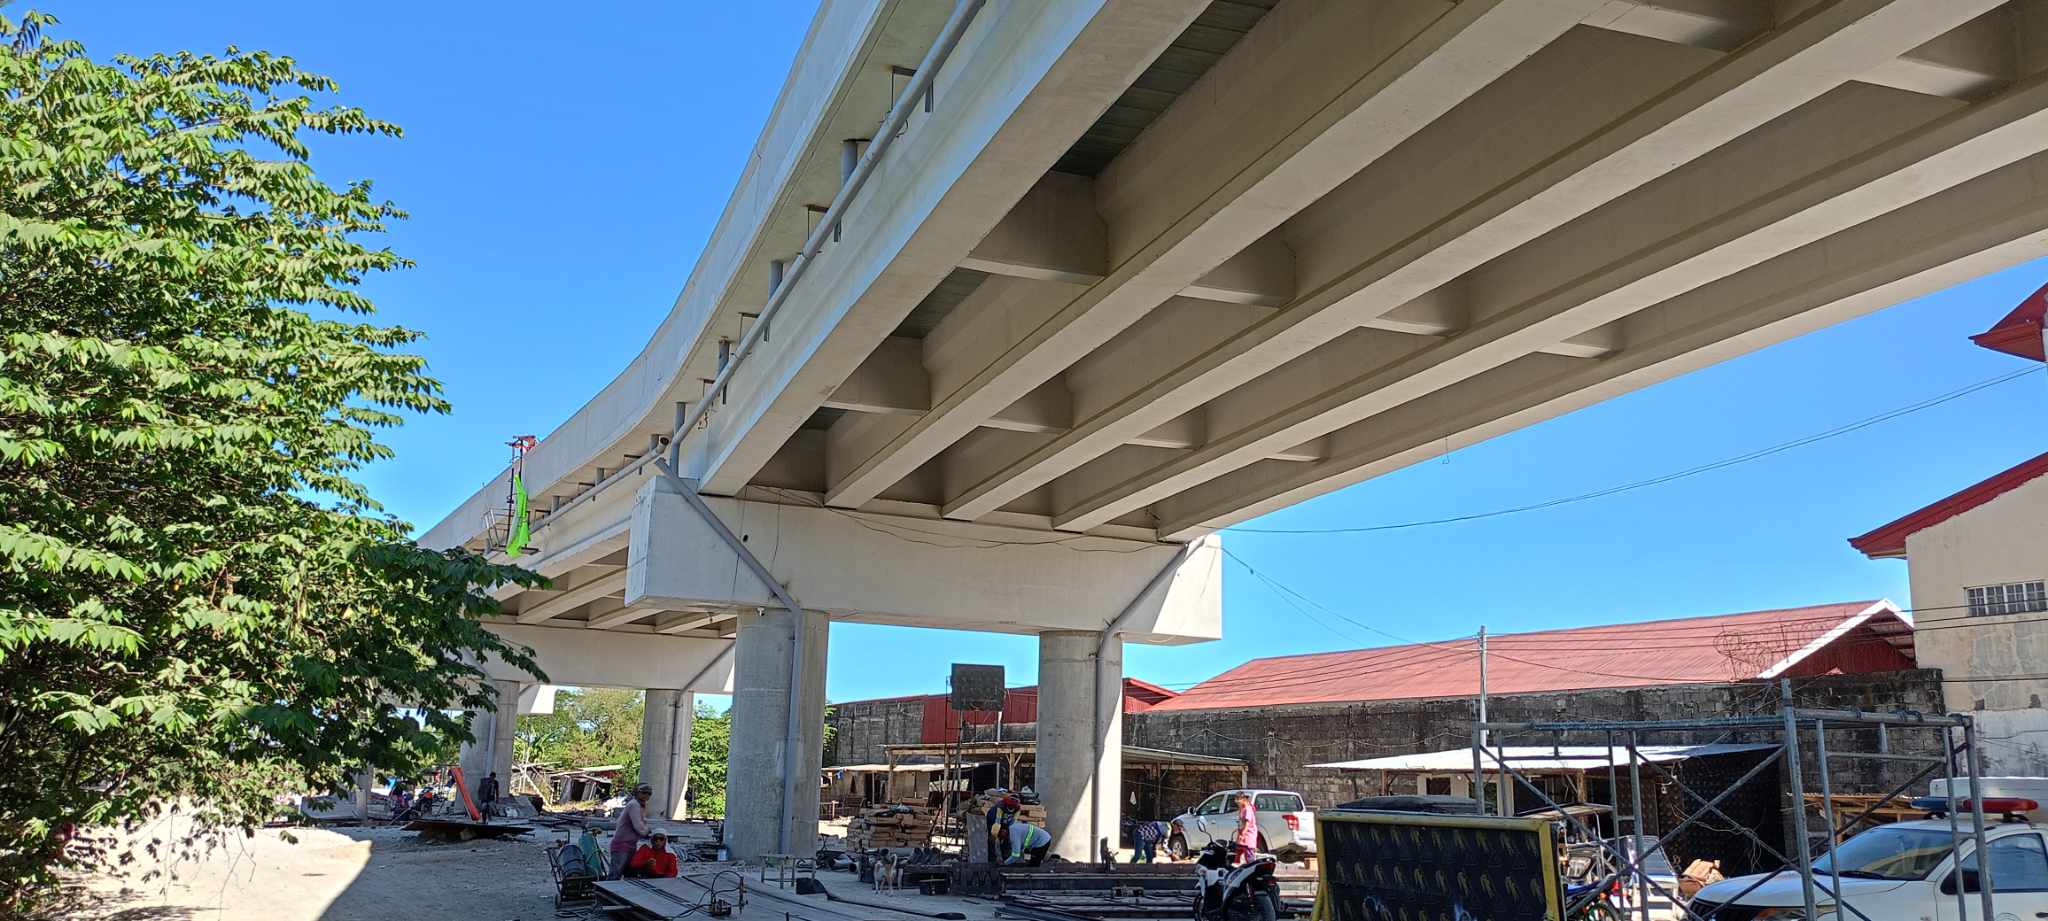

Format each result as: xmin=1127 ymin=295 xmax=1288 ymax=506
xmin=1032 ymin=630 xmax=1124 ymax=860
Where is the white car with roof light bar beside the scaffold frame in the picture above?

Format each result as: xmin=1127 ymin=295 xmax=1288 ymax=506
xmin=1690 ymin=796 xmax=2048 ymax=921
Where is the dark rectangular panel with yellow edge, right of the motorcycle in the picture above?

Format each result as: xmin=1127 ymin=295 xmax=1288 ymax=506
xmin=1315 ymin=810 xmax=1565 ymax=921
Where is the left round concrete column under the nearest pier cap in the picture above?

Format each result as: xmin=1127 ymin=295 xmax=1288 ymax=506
xmin=725 ymin=608 xmax=829 ymax=860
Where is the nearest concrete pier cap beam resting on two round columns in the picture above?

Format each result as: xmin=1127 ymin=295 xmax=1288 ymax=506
xmin=630 ymin=478 xmax=1221 ymax=645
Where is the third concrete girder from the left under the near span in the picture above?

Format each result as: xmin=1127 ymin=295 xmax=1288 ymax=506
xmin=948 ymin=0 xmax=1997 ymax=530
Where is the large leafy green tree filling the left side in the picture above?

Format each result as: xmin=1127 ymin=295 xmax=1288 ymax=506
xmin=0 ymin=12 xmax=539 ymax=915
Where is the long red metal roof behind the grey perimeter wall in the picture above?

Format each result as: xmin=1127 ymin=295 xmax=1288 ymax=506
xmin=1153 ymin=602 xmax=1913 ymax=712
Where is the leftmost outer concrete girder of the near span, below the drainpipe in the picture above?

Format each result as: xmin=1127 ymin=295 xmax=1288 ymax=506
xmin=682 ymin=0 xmax=1204 ymax=495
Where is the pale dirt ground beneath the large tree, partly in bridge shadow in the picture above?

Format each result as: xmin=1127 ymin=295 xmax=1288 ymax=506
xmin=63 ymin=827 xmax=559 ymax=921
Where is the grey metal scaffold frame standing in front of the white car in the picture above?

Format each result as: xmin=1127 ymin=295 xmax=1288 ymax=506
xmin=1473 ymin=679 xmax=1997 ymax=921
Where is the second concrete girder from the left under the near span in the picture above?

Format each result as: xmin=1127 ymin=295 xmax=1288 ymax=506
xmin=829 ymin=0 xmax=1602 ymax=512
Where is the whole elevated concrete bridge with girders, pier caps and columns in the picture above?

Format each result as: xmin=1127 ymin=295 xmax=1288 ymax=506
xmin=424 ymin=0 xmax=2048 ymax=858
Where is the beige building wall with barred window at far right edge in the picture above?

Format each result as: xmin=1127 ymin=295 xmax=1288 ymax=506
xmin=1907 ymin=479 xmax=2048 ymax=774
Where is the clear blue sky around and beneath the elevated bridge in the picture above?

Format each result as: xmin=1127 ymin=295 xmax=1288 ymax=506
xmin=59 ymin=0 xmax=2048 ymax=700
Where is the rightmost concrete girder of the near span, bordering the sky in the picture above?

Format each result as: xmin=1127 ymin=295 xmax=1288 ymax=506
xmin=1155 ymin=154 xmax=2048 ymax=538
